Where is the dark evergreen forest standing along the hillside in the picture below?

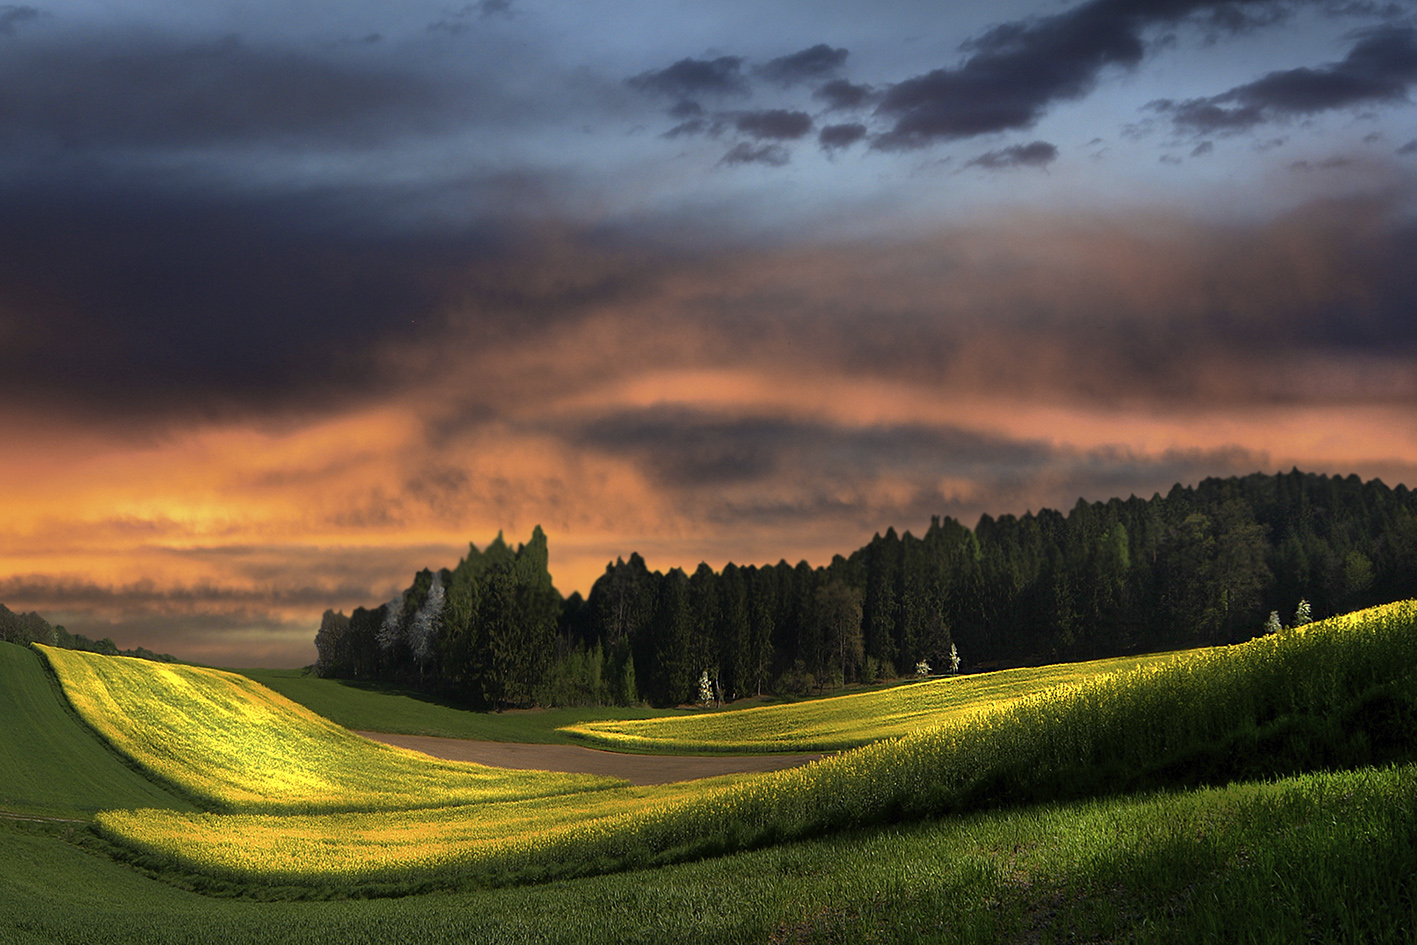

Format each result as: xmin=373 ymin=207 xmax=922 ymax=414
xmin=316 ymin=470 xmax=1417 ymax=706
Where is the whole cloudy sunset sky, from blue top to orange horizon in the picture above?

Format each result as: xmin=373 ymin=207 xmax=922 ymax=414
xmin=0 ymin=0 xmax=1417 ymax=666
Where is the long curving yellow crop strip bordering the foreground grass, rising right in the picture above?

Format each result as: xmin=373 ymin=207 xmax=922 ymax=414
xmin=85 ymin=602 xmax=1417 ymax=888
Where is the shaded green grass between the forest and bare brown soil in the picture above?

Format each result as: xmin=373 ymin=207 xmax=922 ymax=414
xmin=232 ymin=669 xmax=683 ymax=745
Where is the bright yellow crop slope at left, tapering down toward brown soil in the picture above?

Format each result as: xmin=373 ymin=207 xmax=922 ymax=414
xmin=38 ymin=646 xmax=623 ymax=812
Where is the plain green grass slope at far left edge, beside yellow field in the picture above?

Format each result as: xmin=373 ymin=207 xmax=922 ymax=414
xmin=0 ymin=643 xmax=193 ymax=817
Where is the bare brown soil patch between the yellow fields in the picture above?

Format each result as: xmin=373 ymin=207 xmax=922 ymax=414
xmin=356 ymin=731 xmax=822 ymax=785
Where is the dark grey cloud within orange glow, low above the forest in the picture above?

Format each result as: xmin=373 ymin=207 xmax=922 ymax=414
xmin=563 ymin=408 xmax=1050 ymax=489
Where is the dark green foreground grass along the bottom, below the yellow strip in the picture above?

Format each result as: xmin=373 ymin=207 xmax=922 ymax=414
xmin=0 ymin=765 xmax=1417 ymax=945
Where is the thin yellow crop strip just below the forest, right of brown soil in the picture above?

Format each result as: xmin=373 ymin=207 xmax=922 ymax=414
xmin=564 ymin=650 xmax=1196 ymax=754
